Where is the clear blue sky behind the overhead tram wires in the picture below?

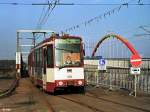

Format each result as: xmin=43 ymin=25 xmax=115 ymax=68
xmin=0 ymin=0 xmax=150 ymax=59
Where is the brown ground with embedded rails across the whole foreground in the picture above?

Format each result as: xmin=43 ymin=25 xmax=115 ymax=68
xmin=0 ymin=78 xmax=150 ymax=112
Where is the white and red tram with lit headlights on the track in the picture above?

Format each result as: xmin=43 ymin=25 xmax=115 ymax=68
xmin=28 ymin=35 xmax=85 ymax=92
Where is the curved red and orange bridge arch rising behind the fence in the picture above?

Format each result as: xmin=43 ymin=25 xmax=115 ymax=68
xmin=92 ymin=34 xmax=140 ymax=57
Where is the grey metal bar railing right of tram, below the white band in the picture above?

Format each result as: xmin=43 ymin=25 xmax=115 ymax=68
xmin=85 ymin=65 xmax=150 ymax=93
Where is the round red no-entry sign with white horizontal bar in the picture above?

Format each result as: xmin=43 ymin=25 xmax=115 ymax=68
xmin=130 ymin=55 xmax=142 ymax=67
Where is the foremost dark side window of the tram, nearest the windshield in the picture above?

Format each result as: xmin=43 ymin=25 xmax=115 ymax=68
xmin=47 ymin=45 xmax=54 ymax=68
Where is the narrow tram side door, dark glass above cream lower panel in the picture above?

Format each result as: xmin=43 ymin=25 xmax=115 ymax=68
xmin=43 ymin=47 xmax=47 ymax=89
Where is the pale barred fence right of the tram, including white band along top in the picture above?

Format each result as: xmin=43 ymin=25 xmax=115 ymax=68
xmin=85 ymin=59 xmax=150 ymax=93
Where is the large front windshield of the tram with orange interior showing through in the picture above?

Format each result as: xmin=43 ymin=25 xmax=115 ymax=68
xmin=55 ymin=39 xmax=81 ymax=68
